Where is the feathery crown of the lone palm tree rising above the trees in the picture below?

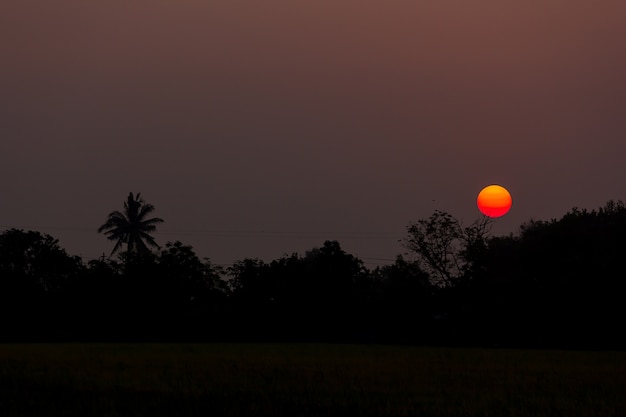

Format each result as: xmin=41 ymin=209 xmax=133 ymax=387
xmin=98 ymin=193 xmax=163 ymax=256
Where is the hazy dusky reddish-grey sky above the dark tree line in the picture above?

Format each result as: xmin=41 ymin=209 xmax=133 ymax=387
xmin=0 ymin=0 xmax=626 ymax=267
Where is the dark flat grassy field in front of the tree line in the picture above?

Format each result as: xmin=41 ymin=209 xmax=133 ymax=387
xmin=0 ymin=344 xmax=626 ymax=417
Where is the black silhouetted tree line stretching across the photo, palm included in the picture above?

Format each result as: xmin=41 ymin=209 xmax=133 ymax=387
xmin=0 ymin=193 xmax=626 ymax=348
